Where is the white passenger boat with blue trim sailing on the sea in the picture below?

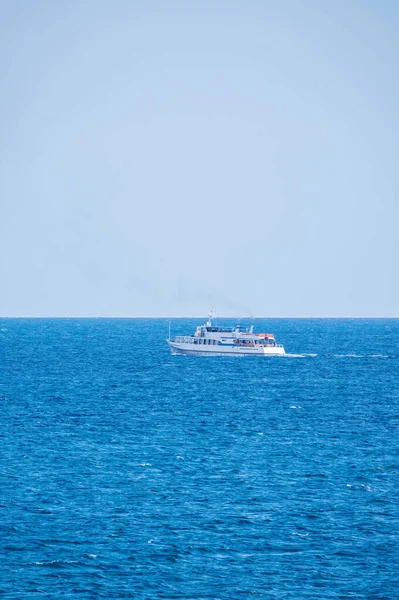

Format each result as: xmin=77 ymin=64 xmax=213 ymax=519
xmin=166 ymin=312 xmax=285 ymax=356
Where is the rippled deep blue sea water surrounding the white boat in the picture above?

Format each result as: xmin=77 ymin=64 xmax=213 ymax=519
xmin=0 ymin=319 xmax=399 ymax=600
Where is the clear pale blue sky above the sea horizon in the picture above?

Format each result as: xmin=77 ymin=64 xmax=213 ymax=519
xmin=0 ymin=0 xmax=399 ymax=317
